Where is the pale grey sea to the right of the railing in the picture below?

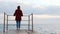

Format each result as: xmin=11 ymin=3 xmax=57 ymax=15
xmin=34 ymin=24 xmax=60 ymax=34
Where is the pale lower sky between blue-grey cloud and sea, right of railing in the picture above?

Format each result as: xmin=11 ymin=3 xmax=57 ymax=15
xmin=33 ymin=15 xmax=60 ymax=24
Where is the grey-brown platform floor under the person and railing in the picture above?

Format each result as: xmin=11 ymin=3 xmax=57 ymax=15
xmin=0 ymin=30 xmax=38 ymax=34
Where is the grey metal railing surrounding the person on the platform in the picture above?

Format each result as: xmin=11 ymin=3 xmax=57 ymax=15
xmin=3 ymin=12 xmax=33 ymax=32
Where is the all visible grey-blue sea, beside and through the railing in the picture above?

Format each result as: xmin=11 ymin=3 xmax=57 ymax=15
xmin=0 ymin=24 xmax=60 ymax=34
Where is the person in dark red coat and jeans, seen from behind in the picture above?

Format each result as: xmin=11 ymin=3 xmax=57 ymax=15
xmin=14 ymin=6 xmax=23 ymax=30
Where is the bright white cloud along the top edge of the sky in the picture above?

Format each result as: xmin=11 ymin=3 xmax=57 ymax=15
xmin=0 ymin=0 xmax=60 ymax=6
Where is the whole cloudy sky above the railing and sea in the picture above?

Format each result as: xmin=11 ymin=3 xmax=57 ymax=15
xmin=0 ymin=0 xmax=60 ymax=24
